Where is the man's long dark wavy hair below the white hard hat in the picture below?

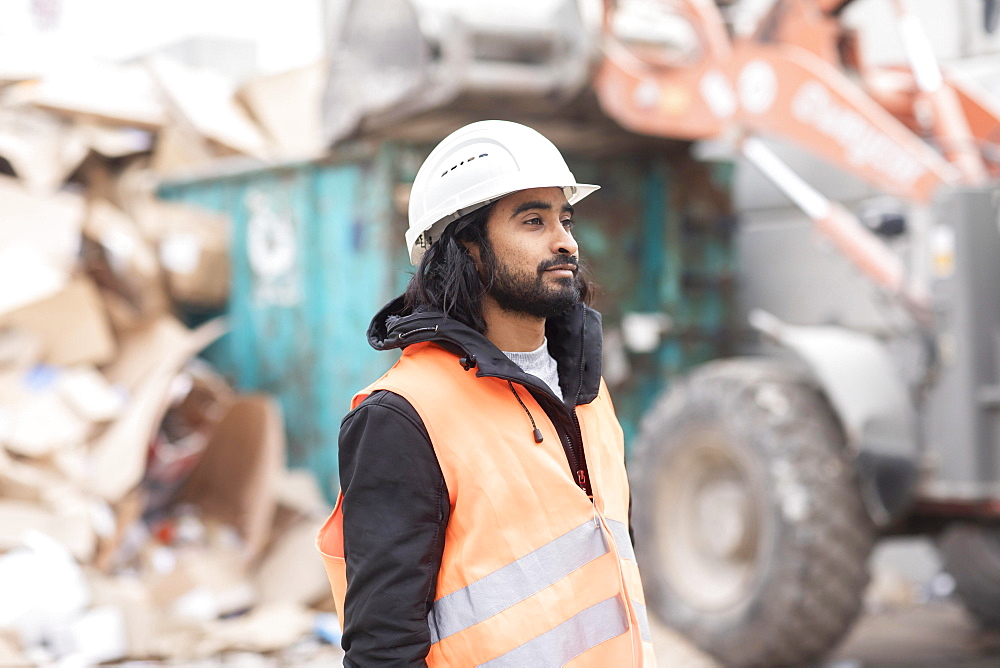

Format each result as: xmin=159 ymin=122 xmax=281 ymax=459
xmin=403 ymin=202 xmax=594 ymax=334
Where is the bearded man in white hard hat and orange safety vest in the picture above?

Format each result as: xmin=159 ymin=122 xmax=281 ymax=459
xmin=318 ymin=121 xmax=653 ymax=668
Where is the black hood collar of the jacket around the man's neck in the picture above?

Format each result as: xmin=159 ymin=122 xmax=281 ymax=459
xmin=368 ymin=296 xmax=602 ymax=404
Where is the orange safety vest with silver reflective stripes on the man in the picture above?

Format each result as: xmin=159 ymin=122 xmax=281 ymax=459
xmin=317 ymin=343 xmax=655 ymax=668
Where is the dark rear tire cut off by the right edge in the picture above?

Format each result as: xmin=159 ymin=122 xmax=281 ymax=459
xmin=940 ymin=524 xmax=1000 ymax=629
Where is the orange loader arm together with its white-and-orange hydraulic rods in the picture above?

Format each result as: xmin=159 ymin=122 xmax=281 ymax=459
xmin=594 ymin=0 xmax=1000 ymax=326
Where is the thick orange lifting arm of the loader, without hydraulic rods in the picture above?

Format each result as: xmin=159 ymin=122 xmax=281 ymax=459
xmin=595 ymin=0 xmax=976 ymax=202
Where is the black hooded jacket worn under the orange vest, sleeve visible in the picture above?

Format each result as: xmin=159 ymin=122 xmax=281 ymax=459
xmin=339 ymin=298 xmax=601 ymax=667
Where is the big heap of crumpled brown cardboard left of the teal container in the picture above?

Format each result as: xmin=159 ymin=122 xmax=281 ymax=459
xmin=0 ymin=62 xmax=329 ymax=666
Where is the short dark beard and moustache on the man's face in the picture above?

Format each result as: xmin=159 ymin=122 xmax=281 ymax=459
xmin=482 ymin=244 xmax=580 ymax=318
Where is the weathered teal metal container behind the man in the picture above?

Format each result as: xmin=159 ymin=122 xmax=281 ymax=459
xmin=160 ymin=143 xmax=735 ymax=499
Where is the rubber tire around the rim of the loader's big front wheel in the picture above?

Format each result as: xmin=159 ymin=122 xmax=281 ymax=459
xmin=633 ymin=359 xmax=875 ymax=665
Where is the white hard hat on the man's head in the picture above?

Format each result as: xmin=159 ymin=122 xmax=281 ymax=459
xmin=406 ymin=121 xmax=600 ymax=265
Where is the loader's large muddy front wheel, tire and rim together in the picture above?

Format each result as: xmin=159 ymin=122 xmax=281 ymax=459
xmin=631 ymin=359 xmax=874 ymax=666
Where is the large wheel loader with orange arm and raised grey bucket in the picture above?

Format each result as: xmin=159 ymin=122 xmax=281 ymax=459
xmin=327 ymin=0 xmax=1000 ymax=665
